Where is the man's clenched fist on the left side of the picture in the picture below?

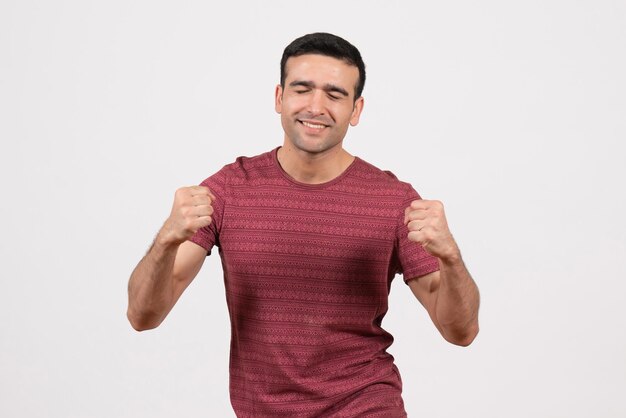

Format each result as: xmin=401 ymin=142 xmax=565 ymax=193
xmin=159 ymin=186 xmax=215 ymax=244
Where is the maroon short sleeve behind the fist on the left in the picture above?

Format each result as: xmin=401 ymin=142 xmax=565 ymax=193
xmin=189 ymin=167 xmax=227 ymax=255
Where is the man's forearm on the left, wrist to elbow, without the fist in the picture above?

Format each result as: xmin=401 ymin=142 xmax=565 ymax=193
xmin=127 ymin=234 xmax=179 ymax=330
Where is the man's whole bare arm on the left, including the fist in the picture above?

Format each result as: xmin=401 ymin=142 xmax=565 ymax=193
xmin=127 ymin=186 xmax=214 ymax=331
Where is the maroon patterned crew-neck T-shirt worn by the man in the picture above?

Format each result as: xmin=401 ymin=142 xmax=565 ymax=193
xmin=191 ymin=149 xmax=439 ymax=417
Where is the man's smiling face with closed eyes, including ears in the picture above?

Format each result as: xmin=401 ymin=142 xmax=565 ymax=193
xmin=276 ymin=54 xmax=363 ymax=154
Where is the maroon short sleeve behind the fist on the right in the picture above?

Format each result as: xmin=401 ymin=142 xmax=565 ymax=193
xmin=396 ymin=185 xmax=439 ymax=282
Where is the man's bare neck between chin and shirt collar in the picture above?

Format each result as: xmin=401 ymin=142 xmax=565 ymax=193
xmin=277 ymin=141 xmax=354 ymax=184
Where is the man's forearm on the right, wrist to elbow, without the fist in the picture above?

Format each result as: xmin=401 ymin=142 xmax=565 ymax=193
xmin=435 ymin=255 xmax=480 ymax=346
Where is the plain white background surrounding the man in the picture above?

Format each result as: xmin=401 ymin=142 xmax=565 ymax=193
xmin=0 ymin=0 xmax=626 ymax=418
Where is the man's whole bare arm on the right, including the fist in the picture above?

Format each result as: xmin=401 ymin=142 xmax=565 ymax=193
xmin=405 ymin=200 xmax=480 ymax=346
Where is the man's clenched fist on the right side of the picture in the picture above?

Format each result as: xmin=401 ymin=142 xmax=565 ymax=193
xmin=404 ymin=200 xmax=459 ymax=260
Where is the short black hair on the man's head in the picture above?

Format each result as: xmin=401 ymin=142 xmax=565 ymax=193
xmin=280 ymin=32 xmax=365 ymax=100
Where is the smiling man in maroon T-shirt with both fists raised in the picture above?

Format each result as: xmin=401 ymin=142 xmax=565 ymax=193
xmin=128 ymin=33 xmax=479 ymax=417
